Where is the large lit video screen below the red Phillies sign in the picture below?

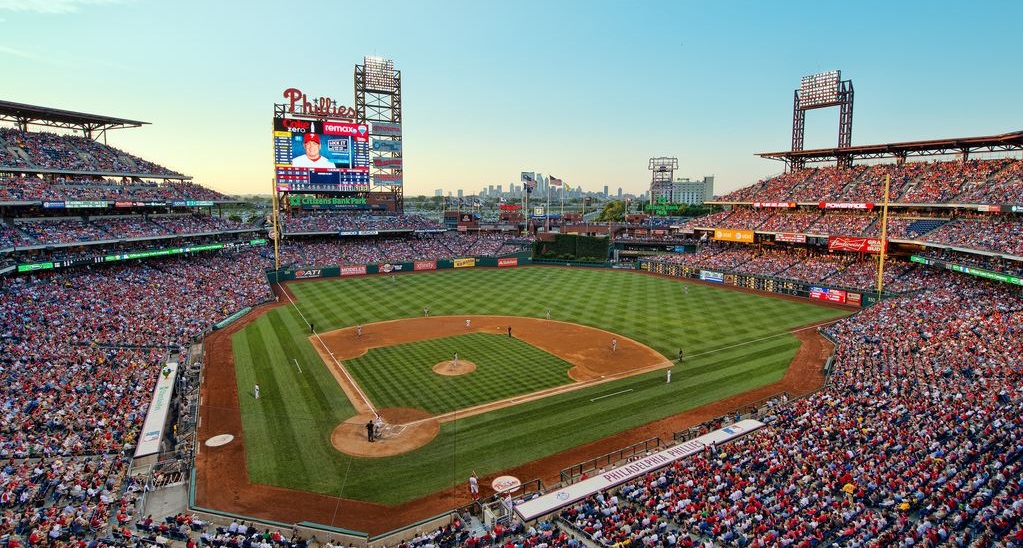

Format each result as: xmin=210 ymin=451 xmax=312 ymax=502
xmin=273 ymin=118 xmax=369 ymax=192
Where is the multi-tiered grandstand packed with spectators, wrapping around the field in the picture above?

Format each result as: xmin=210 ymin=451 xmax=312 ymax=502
xmin=0 ymin=87 xmax=1023 ymax=548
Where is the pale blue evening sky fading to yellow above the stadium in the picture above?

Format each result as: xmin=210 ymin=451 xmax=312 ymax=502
xmin=0 ymin=0 xmax=1023 ymax=195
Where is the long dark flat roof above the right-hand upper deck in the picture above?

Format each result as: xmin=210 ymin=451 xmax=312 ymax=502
xmin=757 ymin=131 xmax=1023 ymax=164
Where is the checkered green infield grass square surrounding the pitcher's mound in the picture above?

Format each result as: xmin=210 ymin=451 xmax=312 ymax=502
xmin=345 ymin=333 xmax=572 ymax=415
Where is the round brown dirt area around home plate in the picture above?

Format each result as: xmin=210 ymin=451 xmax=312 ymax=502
xmin=330 ymin=407 xmax=441 ymax=457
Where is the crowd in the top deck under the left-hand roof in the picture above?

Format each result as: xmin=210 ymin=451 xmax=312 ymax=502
xmin=0 ymin=128 xmax=181 ymax=176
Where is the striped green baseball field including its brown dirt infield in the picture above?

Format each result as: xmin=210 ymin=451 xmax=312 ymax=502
xmin=202 ymin=267 xmax=849 ymax=522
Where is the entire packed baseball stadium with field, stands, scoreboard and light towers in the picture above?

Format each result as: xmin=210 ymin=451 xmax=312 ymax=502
xmin=0 ymin=43 xmax=1023 ymax=548
